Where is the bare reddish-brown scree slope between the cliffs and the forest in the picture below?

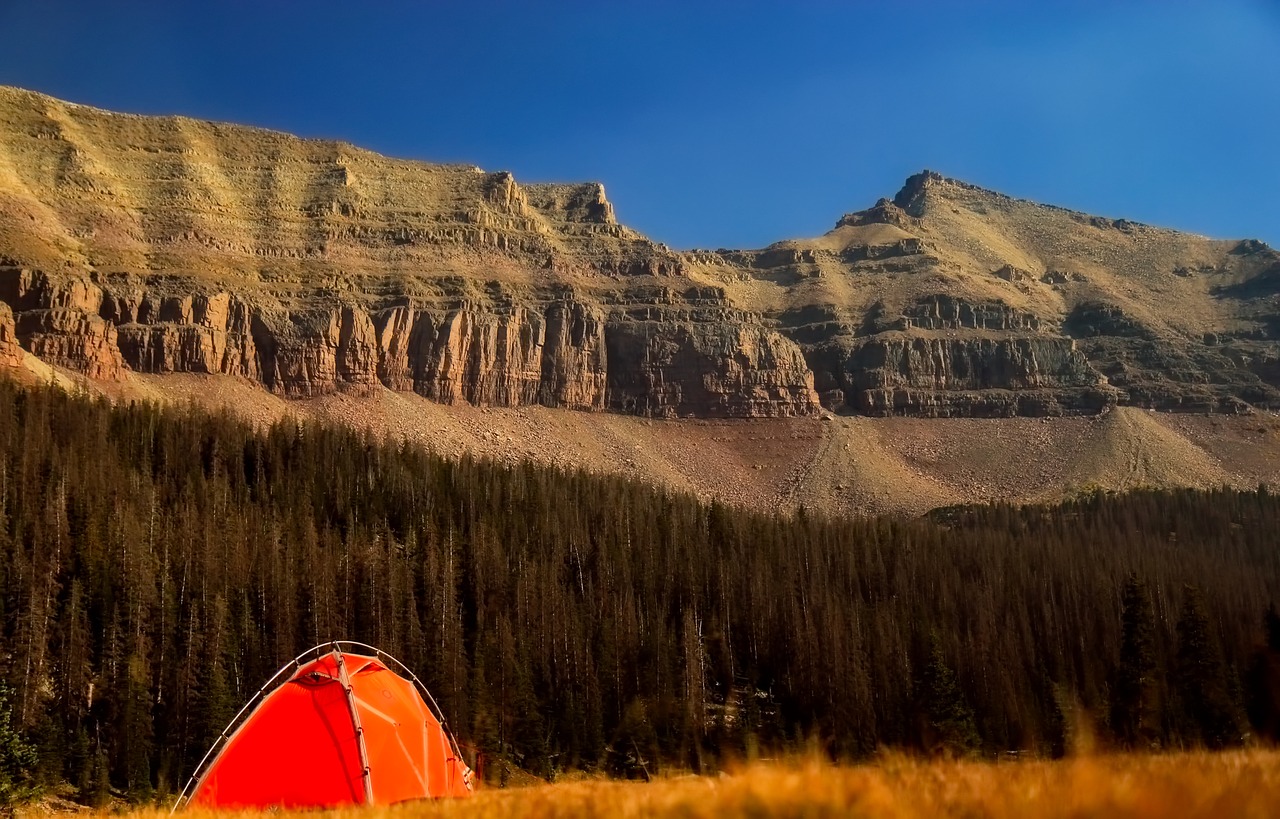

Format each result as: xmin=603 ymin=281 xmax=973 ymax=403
xmin=85 ymin=372 xmax=1280 ymax=514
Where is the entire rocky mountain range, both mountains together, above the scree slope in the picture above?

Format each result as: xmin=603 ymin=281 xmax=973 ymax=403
xmin=0 ymin=88 xmax=1280 ymax=417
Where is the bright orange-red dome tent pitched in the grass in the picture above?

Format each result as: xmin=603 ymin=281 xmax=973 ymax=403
xmin=175 ymin=641 xmax=471 ymax=807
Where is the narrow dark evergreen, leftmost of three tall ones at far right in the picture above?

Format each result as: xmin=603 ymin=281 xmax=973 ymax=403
xmin=1111 ymin=575 xmax=1157 ymax=747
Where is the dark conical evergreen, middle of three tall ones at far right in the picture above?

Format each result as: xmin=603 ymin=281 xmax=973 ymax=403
xmin=1175 ymin=586 xmax=1240 ymax=747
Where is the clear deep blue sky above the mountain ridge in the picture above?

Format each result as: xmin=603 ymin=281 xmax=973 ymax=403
xmin=0 ymin=0 xmax=1280 ymax=247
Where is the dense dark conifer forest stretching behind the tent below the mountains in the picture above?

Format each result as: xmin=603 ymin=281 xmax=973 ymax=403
xmin=0 ymin=383 xmax=1280 ymax=802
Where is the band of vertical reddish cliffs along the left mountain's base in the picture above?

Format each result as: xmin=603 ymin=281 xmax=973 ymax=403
xmin=0 ymin=257 xmax=818 ymax=417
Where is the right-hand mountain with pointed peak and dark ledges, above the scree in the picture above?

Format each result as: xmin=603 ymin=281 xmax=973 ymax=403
xmin=711 ymin=171 xmax=1280 ymax=417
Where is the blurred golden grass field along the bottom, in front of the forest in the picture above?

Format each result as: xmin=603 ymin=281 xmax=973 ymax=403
xmin=55 ymin=750 xmax=1280 ymax=819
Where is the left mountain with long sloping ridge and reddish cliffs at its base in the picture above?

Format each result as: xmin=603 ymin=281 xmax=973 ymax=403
xmin=0 ymin=91 xmax=818 ymax=416
